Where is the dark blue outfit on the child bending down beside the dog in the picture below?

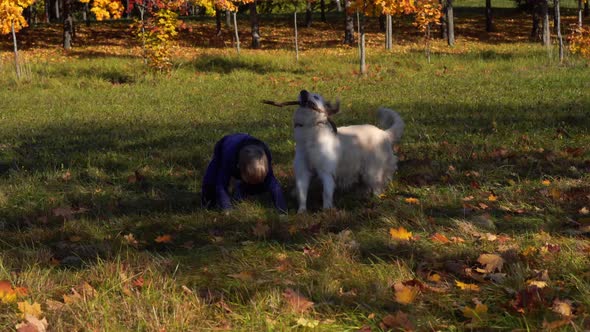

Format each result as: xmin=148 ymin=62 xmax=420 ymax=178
xmin=201 ymin=134 xmax=287 ymax=213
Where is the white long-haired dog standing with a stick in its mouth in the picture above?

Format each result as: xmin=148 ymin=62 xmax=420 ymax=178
xmin=293 ymin=90 xmax=404 ymax=213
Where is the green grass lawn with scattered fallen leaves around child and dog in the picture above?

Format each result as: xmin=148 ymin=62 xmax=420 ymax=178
xmin=0 ymin=16 xmax=590 ymax=331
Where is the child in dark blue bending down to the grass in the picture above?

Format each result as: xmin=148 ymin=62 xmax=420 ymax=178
xmin=201 ymin=134 xmax=287 ymax=213
